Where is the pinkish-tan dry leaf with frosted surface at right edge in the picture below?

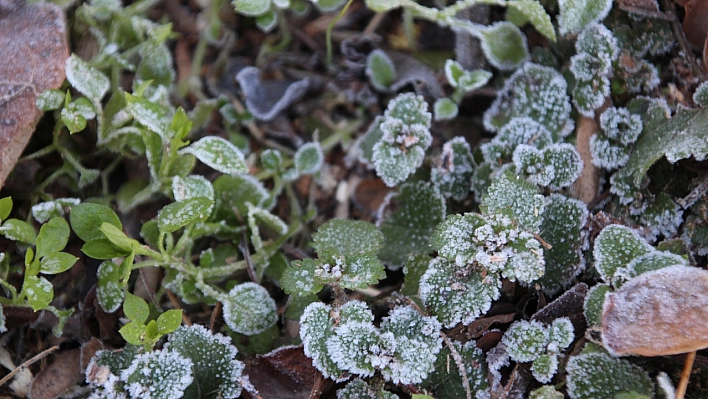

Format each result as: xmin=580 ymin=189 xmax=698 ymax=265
xmin=602 ymin=265 xmax=708 ymax=356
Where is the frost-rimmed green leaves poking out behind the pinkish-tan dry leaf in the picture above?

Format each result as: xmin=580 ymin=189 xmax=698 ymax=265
xmin=584 ymin=225 xmax=688 ymax=326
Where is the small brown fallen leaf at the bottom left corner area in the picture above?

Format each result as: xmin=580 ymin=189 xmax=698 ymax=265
xmin=30 ymin=349 xmax=83 ymax=399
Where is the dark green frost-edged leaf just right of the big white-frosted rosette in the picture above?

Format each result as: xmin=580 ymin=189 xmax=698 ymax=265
xmin=536 ymin=194 xmax=588 ymax=295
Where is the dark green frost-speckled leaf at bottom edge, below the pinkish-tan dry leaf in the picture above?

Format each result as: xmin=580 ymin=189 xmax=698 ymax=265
xmin=566 ymin=349 xmax=654 ymax=399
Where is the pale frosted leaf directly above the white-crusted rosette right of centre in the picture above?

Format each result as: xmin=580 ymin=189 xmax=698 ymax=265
xmin=480 ymin=173 xmax=545 ymax=233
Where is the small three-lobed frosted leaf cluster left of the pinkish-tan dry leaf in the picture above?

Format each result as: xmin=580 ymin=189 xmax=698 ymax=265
xmin=502 ymin=317 xmax=575 ymax=384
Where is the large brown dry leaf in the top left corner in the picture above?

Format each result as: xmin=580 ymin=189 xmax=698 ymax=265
xmin=0 ymin=2 xmax=69 ymax=188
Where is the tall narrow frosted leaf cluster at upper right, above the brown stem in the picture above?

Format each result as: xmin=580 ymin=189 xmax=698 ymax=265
xmin=570 ymin=24 xmax=619 ymax=118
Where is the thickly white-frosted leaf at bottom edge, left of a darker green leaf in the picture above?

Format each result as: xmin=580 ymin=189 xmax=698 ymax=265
xmin=120 ymin=350 xmax=194 ymax=399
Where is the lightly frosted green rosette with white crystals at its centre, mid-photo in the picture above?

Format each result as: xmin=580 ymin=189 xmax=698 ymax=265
xmin=281 ymin=219 xmax=386 ymax=295
